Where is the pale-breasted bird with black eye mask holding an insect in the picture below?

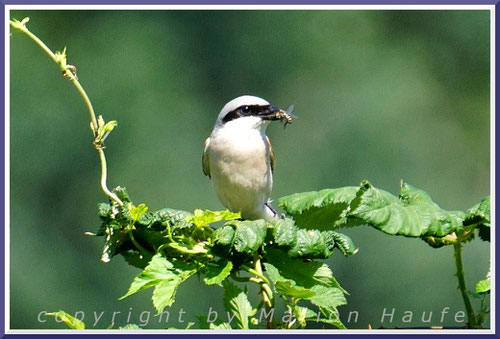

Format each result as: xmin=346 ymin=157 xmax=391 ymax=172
xmin=202 ymin=95 xmax=292 ymax=220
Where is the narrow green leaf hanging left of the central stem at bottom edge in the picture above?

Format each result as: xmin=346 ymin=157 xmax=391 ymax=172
xmin=222 ymin=279 xmax=254 ymax=330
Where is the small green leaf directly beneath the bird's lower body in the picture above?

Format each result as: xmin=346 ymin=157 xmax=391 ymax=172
xmin=230 ymin=220 xmax=267 ymax=254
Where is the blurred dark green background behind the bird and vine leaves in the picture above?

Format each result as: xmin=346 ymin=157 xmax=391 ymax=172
xmin=10 ymin=10 xmax=490 ymax=329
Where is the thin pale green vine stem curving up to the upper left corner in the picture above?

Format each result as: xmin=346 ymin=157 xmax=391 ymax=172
xmin=9 ymin=18 xmax=123 ymax=206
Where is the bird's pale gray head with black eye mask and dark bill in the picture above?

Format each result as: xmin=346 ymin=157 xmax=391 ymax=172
xmin=215 ymin=95 xmax=281 ymax=127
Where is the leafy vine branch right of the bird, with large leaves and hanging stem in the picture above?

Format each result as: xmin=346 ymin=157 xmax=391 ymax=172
xmin=279 ymin=181 xmax=490 ymax=328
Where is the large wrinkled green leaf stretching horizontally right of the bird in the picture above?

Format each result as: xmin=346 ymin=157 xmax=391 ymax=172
xmin=279 ymin=181 xmax=465 ymax=237
